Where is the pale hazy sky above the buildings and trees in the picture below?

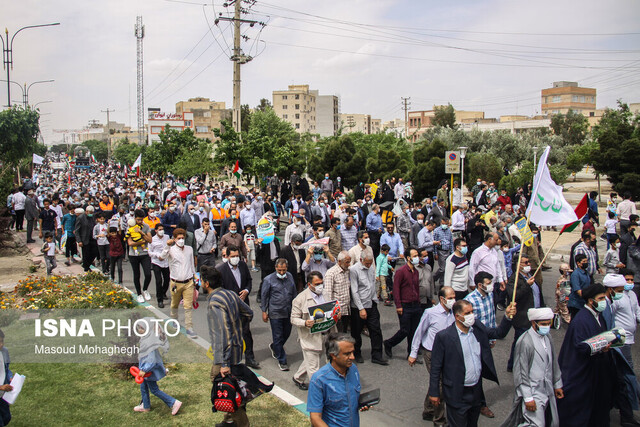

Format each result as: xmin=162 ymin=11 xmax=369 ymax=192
xmin=5 ymin=0 xmax=640 ymax=142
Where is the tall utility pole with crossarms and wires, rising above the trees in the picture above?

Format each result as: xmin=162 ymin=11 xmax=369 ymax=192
xmin=214 ymin=0 xmax=265 ymax=134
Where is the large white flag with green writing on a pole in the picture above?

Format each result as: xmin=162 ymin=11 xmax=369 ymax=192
xmin=527 ymin=146 xmax=578 ymax=226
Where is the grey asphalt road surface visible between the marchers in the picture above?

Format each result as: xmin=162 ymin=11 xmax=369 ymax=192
xmin=102 ymin=231 xmax=640 ymax=426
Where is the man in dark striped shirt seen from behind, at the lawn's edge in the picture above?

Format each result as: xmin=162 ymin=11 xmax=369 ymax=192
xmin=200 ymin=266 xmax=253 ymax=427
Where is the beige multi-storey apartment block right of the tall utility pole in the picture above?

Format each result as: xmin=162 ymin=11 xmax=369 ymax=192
xmin=272 ymin=85 xmax=317 ymax=133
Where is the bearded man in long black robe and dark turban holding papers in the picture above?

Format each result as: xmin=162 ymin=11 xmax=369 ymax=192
xmin=558 ymin=283 xmax=617 ymax=427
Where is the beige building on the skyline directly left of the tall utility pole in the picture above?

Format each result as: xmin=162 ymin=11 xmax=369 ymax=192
xmin=176 ymin=98 xmax=232 ymax=141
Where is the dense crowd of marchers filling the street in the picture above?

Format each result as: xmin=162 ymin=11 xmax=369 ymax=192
xmin=8 ymin=158 xmax=640 ymax=426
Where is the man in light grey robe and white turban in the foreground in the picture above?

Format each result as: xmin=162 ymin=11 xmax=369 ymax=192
xmin=502 ymin=307 xmax=564 ymax=427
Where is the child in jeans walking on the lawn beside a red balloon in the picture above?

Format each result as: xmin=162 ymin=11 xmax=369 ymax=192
xmin=133 ymin=317 xmax=182 ymax=415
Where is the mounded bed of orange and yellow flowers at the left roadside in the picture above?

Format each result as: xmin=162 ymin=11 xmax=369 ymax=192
xmin=8 ymin=272 xmax=136 ymax=310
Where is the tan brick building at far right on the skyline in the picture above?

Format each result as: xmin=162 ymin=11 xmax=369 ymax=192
xmin=541 ymin=81 xmax=596 ymax=116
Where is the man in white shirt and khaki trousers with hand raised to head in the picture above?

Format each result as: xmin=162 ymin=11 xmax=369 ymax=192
xmin=160 ymin=228 xmax=197 ymax=338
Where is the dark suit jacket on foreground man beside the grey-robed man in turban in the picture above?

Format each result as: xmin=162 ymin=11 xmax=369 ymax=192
xmin=428 ymin=316 xmax=511 ymax=408
